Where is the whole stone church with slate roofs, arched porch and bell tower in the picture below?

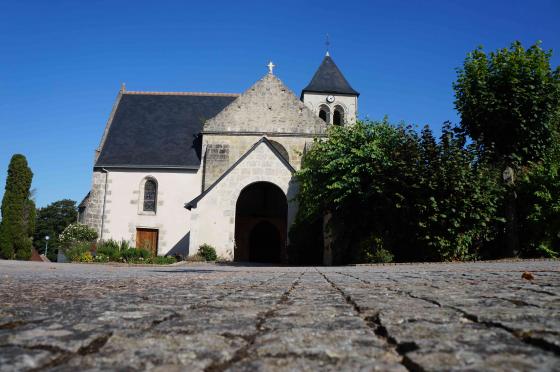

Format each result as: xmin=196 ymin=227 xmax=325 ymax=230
xmin=79 ymin=52 xmax=359 ymax=263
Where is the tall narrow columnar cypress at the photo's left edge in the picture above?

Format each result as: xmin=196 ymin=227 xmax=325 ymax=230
xmin=0 ymin=154 xmax=35 ymax=260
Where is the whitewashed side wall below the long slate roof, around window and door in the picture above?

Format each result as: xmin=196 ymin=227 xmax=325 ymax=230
xmin=100 ymin=170 xmax=201 ymax=255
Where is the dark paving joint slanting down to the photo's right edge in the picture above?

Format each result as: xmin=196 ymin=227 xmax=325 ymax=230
xmin=338 ymin=273 xmax=560 ymax=355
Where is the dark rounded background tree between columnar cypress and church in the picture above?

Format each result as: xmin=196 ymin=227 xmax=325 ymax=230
xmin=33 ymin=199 xmax=78 ymax=260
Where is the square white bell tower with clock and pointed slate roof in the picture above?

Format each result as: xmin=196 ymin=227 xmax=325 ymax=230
xmin=301 ymin=51 xmax=360 ymax=125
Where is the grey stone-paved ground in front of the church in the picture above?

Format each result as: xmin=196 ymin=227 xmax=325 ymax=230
xmin=0 ymin=261 xmax=560 ymax=371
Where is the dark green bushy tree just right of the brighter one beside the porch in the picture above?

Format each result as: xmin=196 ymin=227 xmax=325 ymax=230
xmin=414 ymin=123 xmax=503 ymax=260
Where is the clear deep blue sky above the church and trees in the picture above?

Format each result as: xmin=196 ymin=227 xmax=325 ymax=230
xmin=0 ymin=0 xmax=560 ymax=206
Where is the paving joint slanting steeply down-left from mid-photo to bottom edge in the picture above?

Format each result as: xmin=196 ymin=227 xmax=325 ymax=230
xmin=204 ymin=272 xmax=305 ymax=372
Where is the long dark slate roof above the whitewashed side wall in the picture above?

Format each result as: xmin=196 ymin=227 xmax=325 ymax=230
xmin=95 ymin=92 xmax=238 ymax=169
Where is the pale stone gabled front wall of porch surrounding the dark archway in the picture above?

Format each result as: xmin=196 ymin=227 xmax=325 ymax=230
xmin=191 ymin=142 xmax=297 ymax=260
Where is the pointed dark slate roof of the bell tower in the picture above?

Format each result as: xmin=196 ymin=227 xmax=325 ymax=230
xmin=301 ymin=54 xmax=360 ymax=96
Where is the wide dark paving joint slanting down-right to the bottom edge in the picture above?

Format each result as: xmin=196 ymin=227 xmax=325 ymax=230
xmin=315 ymin=268 xmax=418 ymax=371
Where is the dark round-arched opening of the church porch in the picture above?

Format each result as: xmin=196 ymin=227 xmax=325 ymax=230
xmin=234 ymin=182 xmax=288 ymax=263
